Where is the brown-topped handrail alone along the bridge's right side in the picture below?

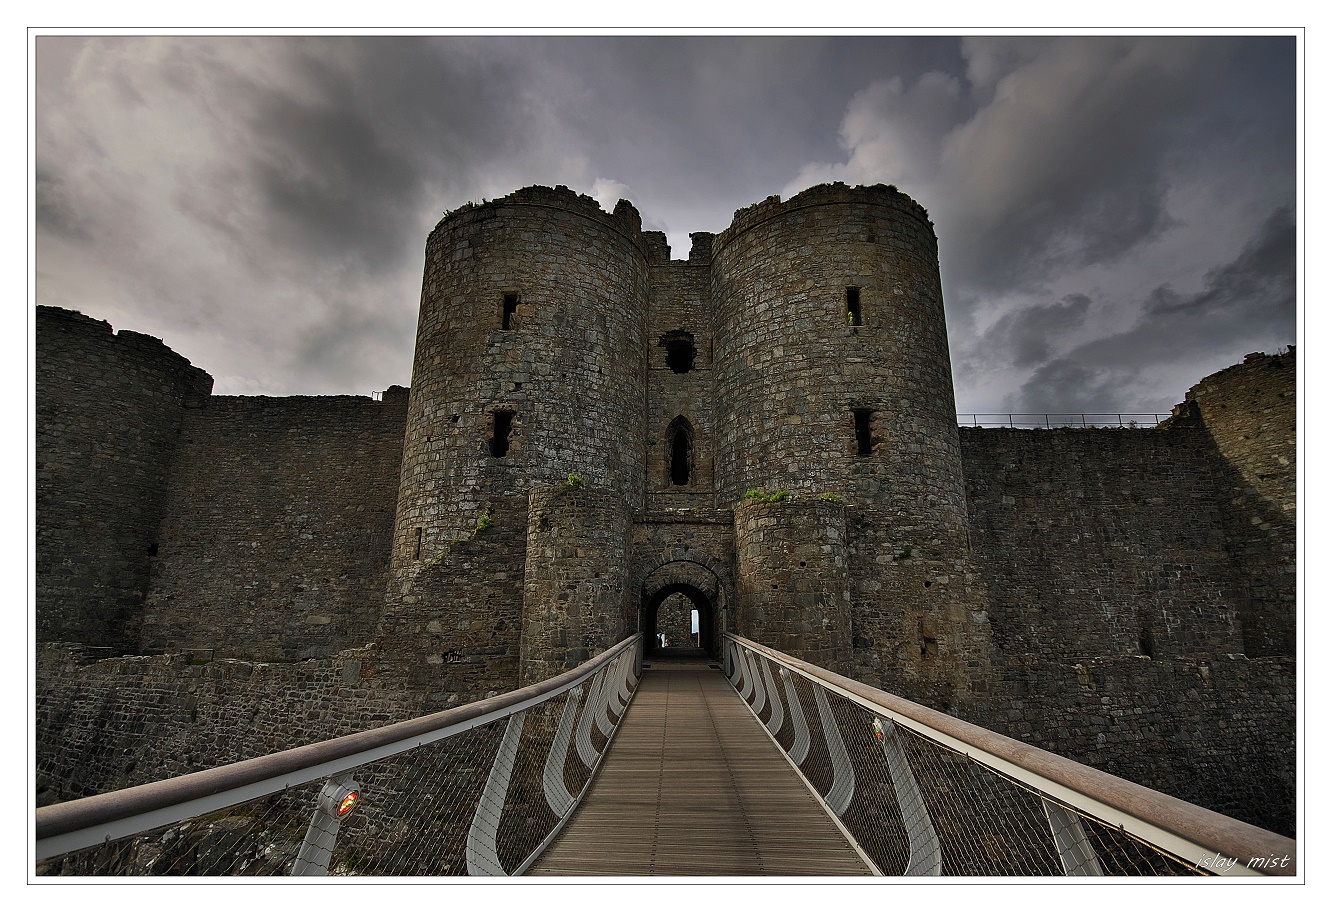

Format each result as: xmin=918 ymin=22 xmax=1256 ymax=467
xmin=726 ymin=634 xmax=1297 ymax=876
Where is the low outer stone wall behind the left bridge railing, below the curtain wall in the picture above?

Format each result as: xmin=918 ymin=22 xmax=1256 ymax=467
xmin=33 ymin=644 xmax=426 ymax=805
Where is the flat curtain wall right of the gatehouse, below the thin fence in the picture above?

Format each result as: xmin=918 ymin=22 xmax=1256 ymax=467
xmin=962 ymin=427 xmax=1243 ymax=660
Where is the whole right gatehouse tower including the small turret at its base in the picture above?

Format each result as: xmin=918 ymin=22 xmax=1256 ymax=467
xmin=711 ymin=184 xmax=988 ymax=707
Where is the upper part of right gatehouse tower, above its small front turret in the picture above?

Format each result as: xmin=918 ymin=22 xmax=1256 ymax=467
xmin=713 ymin=184 xmax=966 ymax=541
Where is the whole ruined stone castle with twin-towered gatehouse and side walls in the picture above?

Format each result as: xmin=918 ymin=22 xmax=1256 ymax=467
xmin=36 ymin=184 xmax=1296 ymax=835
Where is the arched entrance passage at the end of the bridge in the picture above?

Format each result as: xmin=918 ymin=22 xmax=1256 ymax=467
xmin=639 ymin=561 xmax=726 ymax=658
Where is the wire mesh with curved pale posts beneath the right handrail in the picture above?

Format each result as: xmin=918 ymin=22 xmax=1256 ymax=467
xmin=735 ymin=647 xmax=1215 ymax=876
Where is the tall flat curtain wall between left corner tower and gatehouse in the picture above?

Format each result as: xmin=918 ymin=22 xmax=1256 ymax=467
xmin=141 ymin=387 xmax=406 ymax=662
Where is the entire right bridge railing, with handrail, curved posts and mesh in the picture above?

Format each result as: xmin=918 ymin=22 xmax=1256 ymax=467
xmin=726 ymin=634 xmax=1296 ymax=876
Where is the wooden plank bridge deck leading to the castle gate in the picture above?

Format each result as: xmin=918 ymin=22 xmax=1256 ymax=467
xmin=527 ymin=659 xmax=871 ymax=877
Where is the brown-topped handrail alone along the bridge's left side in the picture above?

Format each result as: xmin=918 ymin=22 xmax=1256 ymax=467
xmin=36 ymin=634 xmax=642 ymax=861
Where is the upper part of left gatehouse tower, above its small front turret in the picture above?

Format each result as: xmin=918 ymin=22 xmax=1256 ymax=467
xmin=390 ymin=186 xmax=647 ymax=598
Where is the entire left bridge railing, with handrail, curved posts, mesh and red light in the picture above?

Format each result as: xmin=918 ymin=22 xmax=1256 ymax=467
xmin=36 ymin=634 xmax=642 ymax=876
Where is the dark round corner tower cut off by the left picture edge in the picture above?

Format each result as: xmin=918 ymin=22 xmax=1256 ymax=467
xmin=36 ymin=308 xmax=213 ymax=651
